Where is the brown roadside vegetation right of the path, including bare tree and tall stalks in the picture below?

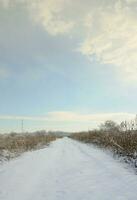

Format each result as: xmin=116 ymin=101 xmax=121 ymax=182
xmin=70 ymin=117 xmax=137 ymax=167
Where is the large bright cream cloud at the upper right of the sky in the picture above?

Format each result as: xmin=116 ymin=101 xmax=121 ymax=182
xmin=80 ymin=2 xmax=137 ymax=81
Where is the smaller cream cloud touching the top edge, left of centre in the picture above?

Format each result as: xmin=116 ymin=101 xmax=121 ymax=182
xmin=30 ymin=0 xmax=74 ymax=35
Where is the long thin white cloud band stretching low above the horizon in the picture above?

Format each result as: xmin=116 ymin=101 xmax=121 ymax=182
xmin=0 ymin=111 xmax=135 ymax=123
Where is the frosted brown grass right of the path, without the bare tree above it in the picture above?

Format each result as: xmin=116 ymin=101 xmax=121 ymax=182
xmin=71 ymin=130 xmax=137 ymax=167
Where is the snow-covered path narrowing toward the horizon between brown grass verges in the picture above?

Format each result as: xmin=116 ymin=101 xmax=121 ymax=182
xmin=0 ymin=138 xmax=137 ymax=200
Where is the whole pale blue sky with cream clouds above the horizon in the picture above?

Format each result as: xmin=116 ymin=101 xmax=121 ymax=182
xmin=0 ymin=0 xmax=137 ymax=132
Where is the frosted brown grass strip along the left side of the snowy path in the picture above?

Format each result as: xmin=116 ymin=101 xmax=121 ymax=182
xmin=0 ymin=131 xmax=57 ymax=162
